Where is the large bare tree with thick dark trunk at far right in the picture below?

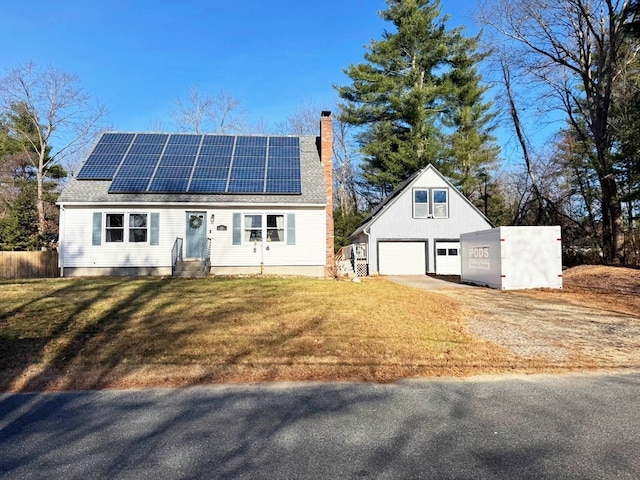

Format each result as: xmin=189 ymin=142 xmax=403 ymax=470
xmin=482 ymin=0 xmax=640 ymax=261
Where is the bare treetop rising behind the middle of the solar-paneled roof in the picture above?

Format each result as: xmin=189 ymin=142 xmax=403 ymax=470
xmin=171 ymin=84 xmax=244 ymax=133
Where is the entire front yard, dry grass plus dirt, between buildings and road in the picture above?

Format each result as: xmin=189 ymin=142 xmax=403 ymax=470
xmin=0 ymin=267 xmax=640 ymax=391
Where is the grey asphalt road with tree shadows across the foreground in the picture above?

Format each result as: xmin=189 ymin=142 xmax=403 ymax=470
xmin=0 ymin=373 xmax=640 ymax=480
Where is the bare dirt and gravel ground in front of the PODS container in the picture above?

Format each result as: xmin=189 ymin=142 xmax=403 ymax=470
xmin=438 ymin=266 xmax=640 ymax=369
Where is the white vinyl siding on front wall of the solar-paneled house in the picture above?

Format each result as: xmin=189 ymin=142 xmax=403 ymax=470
xmin=60 ymin=205 xmax=326 ymax=268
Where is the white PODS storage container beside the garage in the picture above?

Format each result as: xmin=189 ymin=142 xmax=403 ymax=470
xmin=460 ymin=226 xmax=562 ymax=290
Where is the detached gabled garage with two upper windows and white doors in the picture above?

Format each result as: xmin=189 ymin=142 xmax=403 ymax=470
xmin=350 ymin=165 xmax=492 ymax=275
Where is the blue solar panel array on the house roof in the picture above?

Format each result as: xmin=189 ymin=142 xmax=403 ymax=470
xmin=76 ymin=133 xmax=301 ymax=194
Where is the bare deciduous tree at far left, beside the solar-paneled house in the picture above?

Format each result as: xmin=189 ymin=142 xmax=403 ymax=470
xmin=0 ymin=63 xmax=107 ymax=240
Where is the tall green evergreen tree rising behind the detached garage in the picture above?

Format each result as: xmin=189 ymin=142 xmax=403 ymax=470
xmin=336 ymin=0 xmax=497 ymax=197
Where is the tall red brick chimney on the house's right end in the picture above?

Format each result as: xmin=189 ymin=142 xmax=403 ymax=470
xmin=320 ymin=110 xmax=335 ymax=277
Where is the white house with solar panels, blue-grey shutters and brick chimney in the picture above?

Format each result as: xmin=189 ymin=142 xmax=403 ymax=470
xmin=58 ymin=112 xmax=333 ymax=277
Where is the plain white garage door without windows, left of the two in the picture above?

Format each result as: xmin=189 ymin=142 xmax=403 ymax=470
xmin=378 ymin=242 xmax=427 ymax=275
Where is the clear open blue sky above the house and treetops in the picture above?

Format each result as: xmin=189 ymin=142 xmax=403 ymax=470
xmin=0 ymin=0 xmax=475 ymax=133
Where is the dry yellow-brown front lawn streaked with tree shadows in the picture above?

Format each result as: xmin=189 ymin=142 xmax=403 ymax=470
xmin=0 ymin=277 xmax=514 ymax=391
